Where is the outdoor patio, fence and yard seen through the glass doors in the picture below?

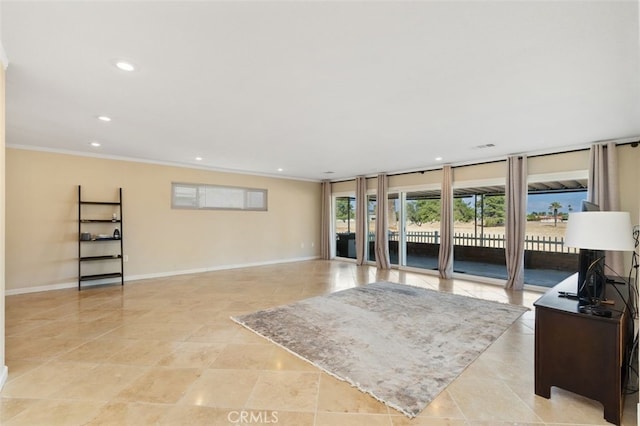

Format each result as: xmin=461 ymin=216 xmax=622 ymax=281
xmin=336 ymin=192 xmax=584 ymax=287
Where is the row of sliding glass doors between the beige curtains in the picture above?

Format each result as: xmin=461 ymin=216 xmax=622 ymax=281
xmin=334 ymin=179 xmax=587 ymax=286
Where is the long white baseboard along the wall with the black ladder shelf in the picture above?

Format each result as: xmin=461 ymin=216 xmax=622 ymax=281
xmin=4 ymin=256 xmax=319 ymax=296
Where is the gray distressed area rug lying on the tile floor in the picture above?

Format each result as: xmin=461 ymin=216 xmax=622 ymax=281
xmin=232 ymin=282 xmax=527 ymax=417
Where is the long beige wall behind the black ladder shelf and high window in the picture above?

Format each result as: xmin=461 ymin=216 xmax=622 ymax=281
xmin=6 ymin=148 xmax=321 ymax=293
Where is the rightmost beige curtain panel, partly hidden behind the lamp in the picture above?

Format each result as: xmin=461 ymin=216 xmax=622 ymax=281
xmin=587 ymin=142 xmax=625 ymax=276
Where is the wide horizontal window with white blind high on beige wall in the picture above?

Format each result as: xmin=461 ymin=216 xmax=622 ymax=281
xmin=171 ymin=182 xmax=267 ymax=211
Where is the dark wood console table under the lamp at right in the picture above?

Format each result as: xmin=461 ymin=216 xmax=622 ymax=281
xmin=534 ymin=274 xmax=633 ymax=425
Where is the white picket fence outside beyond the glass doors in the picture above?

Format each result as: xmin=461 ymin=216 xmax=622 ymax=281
xmin=369 ymin=231 xmax=578 ymax=253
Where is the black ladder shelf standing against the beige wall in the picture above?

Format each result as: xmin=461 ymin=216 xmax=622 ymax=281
xmin=78 ymin=185 xmax=124 ymax=290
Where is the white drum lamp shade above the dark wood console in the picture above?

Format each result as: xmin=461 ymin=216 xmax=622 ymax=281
xmin=564 ymin=212 xmax=635 ymax=251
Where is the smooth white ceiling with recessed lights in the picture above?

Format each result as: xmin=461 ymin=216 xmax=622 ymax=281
xmin=1 ymin=1 xmax=640 ymax=180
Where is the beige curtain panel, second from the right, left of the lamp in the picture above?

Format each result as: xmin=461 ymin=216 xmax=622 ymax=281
xmin=505 ymin=156 xmax=527 ymax=290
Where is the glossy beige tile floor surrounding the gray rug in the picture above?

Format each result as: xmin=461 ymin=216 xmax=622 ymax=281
xmin=0 ymin=260 xmax=637 ymax=426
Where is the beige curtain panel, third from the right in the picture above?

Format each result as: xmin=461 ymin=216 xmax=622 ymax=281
xmin=438 ymin=166 xmax=453 ymax=279
